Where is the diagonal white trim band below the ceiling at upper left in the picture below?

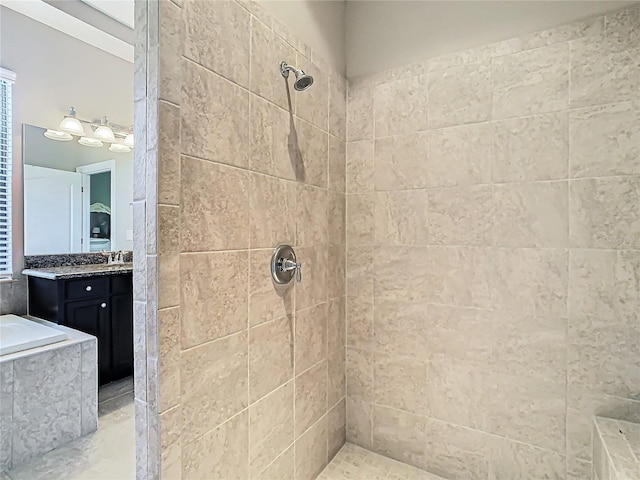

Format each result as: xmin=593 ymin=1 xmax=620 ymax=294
xmin=2 ymin=0 xmax=133 ymax=63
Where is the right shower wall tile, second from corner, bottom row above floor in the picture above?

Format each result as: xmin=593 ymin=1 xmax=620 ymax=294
xmin=373 ymin=405 xmax=426 ymax=467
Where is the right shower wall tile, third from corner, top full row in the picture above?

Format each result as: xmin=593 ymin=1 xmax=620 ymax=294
xmin=428 ymin=62 xmax=491 ymax=128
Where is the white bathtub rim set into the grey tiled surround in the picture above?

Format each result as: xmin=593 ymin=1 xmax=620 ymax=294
xmin=0 ymin=315 xmax=68 ymax=356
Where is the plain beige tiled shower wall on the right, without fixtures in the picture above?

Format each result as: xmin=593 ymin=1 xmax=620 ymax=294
xmin=346 ymin=6 xmax=640 ymax=480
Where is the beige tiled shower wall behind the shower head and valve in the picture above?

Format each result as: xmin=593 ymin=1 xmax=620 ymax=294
xmin=136 ymin=0 xmax=346 ymax=480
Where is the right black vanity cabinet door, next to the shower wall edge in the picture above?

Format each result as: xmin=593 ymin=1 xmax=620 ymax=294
xmin=111 ymin=294 xmax=133 ymax=380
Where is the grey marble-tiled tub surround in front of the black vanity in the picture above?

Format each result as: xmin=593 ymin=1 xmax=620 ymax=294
xmin=0 ymin=320 xmax=98 ymax=470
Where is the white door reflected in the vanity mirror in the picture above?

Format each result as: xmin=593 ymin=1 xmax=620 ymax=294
xmin=24 ymin=165 xmax=83 ymax=255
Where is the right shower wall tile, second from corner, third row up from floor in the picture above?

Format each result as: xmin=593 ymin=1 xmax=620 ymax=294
xmin=374 ymin=298 xmax=430 ymax=361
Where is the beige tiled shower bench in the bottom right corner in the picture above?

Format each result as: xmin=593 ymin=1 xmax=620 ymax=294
xmin=593 ymin=417 xmax=640 ymax=480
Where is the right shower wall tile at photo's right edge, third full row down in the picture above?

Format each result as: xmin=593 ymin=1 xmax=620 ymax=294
xmin=569 ymin=176 xmax=640 ymax=249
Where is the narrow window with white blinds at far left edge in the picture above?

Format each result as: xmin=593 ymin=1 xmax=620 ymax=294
xmin=0 ymin=68 xmax=16 ymax=277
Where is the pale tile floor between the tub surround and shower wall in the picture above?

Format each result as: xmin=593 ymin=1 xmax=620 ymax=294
xmin=1 ymin=378 xmax=136 ymax=480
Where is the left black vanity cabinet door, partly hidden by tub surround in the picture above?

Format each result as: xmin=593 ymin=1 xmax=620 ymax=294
xmin=62 ymin=298 xmax=112 ymax=385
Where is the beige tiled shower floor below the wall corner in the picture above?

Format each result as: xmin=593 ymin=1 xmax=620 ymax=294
xmin=316 ymin=443 xmax=444 ymax=480
